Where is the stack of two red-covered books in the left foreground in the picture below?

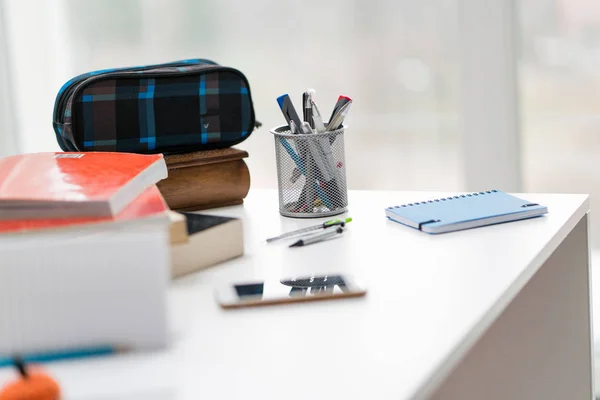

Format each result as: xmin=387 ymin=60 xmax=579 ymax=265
xmin=0 ymin=153 xmax=171 ymax=357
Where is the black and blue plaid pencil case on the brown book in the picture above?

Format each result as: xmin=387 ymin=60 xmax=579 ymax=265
xmin=53 ymin=59 xmax=260 ymax=153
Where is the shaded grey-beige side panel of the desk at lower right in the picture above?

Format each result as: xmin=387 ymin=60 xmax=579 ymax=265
xmin=431 ymin=215 xmax=594 ymax=400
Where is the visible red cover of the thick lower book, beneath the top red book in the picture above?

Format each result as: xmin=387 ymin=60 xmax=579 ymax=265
xmin=0 ymin=185 xmax=169 ymax=234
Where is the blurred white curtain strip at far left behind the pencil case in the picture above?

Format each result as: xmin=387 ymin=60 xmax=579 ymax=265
xmin=1 ymin=0 xmax=72 ymax=152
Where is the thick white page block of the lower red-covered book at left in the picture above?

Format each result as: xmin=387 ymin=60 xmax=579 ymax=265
xmin=0 ymin=187 xmax=170 ymax=358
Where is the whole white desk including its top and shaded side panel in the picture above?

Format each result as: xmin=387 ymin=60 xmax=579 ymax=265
xmin=0 ymin=191 xmax=593 ymax=400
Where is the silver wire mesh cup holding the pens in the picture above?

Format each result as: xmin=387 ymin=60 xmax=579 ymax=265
xmin=271 ymin=125 xmax=348 ymax=218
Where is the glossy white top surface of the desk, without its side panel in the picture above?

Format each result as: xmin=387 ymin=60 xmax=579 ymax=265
xmin=0 ymin=190 xmax=589 ymax=400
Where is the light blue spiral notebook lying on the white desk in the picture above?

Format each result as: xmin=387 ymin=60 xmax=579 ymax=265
xmin=385 ymin=190 xmax=548 ymax=233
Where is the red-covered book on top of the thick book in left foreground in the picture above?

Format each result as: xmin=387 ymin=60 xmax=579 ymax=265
xmin=0 ymin=152 xmax=167 ymax=219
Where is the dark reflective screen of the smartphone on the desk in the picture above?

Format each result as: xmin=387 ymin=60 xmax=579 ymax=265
xmin=234 ymin=275 xmax=356 ymax=302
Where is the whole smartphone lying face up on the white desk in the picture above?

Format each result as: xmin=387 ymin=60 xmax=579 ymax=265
xmin=215 ymin=275 xmax=366 ymax=308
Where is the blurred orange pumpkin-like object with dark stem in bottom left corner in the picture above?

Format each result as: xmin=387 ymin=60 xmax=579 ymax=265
xmin=0 ymin=361 xmax=60 ymax=400
